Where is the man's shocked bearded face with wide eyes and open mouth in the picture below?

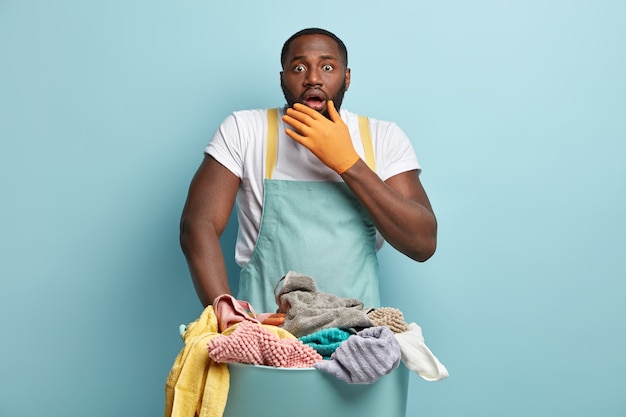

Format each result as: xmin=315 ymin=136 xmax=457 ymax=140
xmin=280 ymin=35 xmax=350 ymax=117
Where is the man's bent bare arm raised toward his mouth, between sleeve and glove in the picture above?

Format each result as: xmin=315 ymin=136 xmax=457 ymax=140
xmin=341 ymin=159 xmax=437 ymax=262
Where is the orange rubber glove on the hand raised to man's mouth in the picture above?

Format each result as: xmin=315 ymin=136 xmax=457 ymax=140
xmin=283 ymin=100 xmax=360 ymax=174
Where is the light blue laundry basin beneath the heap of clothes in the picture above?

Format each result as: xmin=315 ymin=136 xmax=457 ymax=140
xmin=224 ymin=363 xmax=409 ymax=417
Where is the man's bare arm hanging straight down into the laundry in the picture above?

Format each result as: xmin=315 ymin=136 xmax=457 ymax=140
xmin=180 ymin=155 xmax=239 ymax=307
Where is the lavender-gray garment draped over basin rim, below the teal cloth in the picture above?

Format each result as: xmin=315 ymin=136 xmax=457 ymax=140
xmin=313 ymin=326 xmax=401 ymax=384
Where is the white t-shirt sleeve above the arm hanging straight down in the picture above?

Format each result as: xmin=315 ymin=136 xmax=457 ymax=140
xmin=204 ymin=114 xmax=245 ymax=178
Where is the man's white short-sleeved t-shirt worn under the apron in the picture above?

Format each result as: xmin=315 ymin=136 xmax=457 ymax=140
xmin=205 ymin=108 xmax=421 ymax=268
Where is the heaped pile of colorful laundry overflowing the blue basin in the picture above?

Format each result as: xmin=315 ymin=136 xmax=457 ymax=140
xmin=165 ymin=271 xmax=448 ymax=416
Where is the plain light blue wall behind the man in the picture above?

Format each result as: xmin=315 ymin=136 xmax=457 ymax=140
xmin=0 ymin=0 xmax=626 ymax=417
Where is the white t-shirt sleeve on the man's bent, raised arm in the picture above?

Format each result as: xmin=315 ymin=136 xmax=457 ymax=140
xmin=375 ymin=122 xmax=422 ymax=181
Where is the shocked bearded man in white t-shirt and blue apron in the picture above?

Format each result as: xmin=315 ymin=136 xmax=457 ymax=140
xmin=180 ymin=28 xmax=437 ymax=312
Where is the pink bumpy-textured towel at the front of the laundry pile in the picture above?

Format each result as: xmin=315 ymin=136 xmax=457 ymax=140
xmin=208 ymin=321 xmax=323 ymax=368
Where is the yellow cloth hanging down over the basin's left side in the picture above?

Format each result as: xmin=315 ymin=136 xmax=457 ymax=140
xmin=165 ymin=306 xmax=230 ymax=417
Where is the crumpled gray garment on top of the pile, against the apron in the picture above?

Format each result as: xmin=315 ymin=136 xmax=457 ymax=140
xmin=276 ymin=271 xmax=374 ymax=337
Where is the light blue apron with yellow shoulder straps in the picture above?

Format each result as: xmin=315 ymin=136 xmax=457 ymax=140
xmin=237 ymin=109 xmax=380 ymax=312
